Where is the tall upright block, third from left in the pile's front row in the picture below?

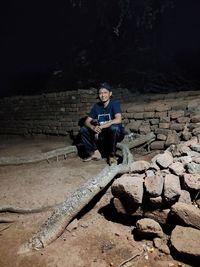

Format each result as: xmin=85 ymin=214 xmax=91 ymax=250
xmin=164 ymin=174 xmax=181 ymax=202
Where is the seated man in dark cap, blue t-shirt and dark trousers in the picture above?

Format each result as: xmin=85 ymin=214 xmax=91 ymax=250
xmin=80 ymin=83 xmax=124 ymax=165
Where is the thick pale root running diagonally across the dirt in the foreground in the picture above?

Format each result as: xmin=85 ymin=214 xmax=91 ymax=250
xmin=19 ymin=143 xmax=133 ymax=253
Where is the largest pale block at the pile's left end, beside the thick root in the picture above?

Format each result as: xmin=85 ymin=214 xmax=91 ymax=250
xmin=111 ymin=174 xmax=144 ymax=205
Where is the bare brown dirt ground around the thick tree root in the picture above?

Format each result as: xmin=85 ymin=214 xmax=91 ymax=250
xmin=0 ymin=136 xmax=193 ymax=267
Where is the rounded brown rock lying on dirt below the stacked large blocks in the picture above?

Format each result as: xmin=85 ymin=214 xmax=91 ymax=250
xmin=136 ymin=218 xmax=164 ymax=238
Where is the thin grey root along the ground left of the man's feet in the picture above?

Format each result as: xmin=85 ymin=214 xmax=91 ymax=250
xmin=0 ymin=146 xmax=77 ymax=165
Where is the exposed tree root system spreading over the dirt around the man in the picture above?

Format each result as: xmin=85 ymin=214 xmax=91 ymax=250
xmin=0 ymin=133 xmax=155 ymax=253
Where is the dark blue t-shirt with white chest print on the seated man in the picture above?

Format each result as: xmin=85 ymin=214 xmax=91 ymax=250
xmin=88 ymin=99 xmax=122 ymax=125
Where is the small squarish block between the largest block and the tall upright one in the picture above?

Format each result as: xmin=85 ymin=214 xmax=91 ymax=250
xmin=144 ymin=174 xmax=164 ymax=197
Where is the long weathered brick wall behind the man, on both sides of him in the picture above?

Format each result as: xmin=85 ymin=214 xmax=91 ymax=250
xmin=0 ymin=88 xmax=200 ymax=149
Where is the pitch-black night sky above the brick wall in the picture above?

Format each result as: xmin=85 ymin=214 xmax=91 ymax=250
xmin=0 ymin=0 xmax=200 ymax=96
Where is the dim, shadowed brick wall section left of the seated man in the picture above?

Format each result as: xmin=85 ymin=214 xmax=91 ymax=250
xmin=0 ymin=89 xmax=129 ymax=135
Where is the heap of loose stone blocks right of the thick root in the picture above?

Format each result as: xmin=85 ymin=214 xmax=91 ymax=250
xmin=111 ymin=137 xmax=200 ymax=263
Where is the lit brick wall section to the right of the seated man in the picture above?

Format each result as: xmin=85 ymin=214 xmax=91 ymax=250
xmin=122 ymin=91 xmax=200 ymax=149
